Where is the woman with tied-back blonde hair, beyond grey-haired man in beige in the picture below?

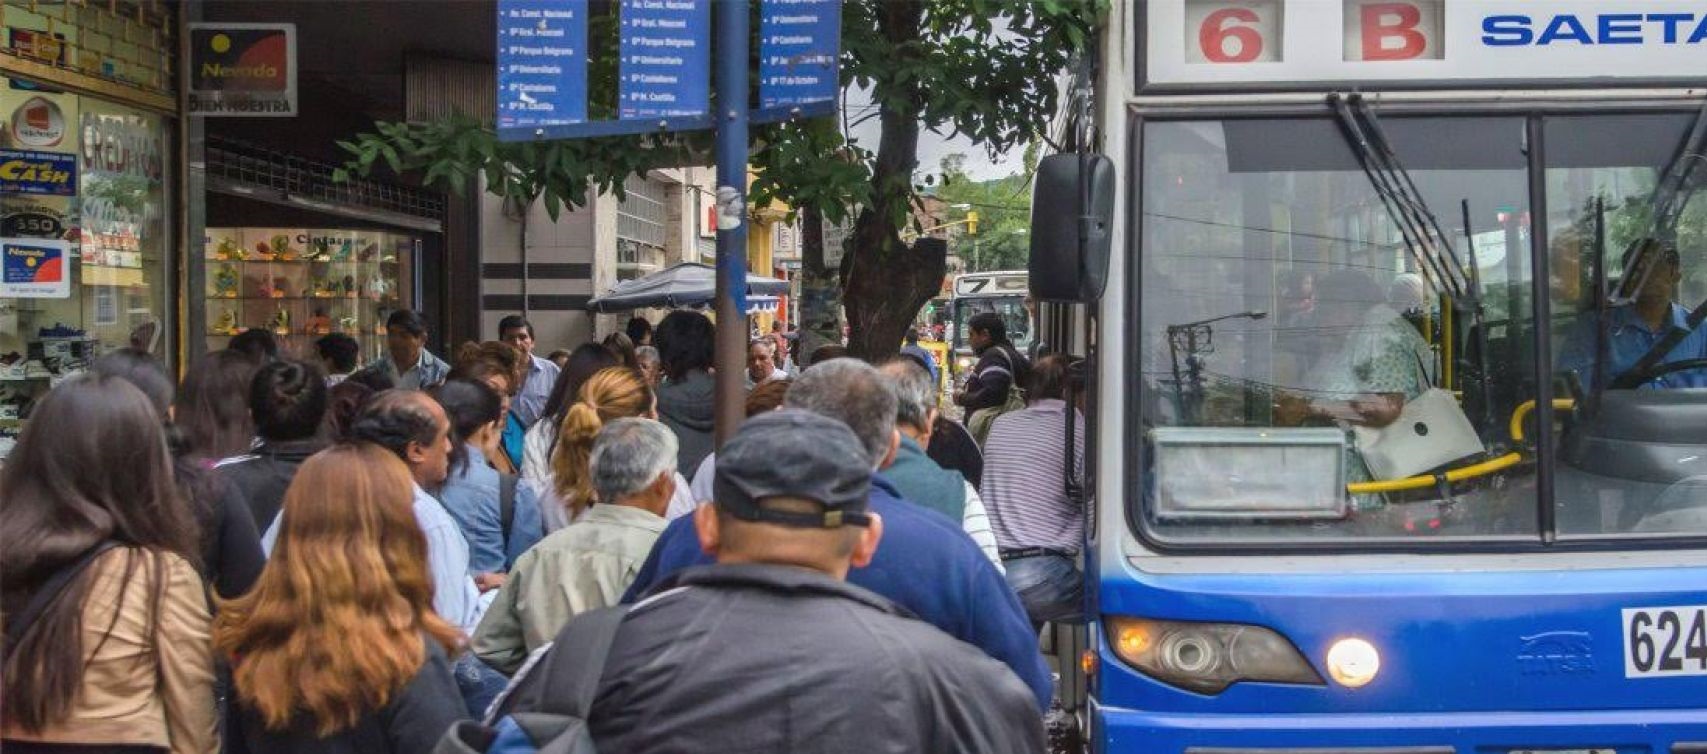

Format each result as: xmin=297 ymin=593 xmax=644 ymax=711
xmin=539 ymin=367 xmax=695 ymax=532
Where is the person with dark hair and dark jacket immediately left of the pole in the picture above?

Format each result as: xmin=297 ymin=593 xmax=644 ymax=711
xmin=652 ymin=309 xmax=717 ymax=474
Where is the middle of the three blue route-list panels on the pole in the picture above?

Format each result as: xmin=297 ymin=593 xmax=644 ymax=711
xmin=616 ymin=0 xmax=712 ymax=121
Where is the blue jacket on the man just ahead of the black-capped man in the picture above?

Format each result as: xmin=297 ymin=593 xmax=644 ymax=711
xmin=623 ymin=476 xmax=1053 ymax=710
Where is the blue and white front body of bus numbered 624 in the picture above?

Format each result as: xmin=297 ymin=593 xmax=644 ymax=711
xmin=1081 ymin=0 xmax=1707 ymax=754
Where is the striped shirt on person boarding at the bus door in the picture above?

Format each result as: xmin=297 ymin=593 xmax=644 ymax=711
xmin=982 ymin=399 xmax=1084 ymax=553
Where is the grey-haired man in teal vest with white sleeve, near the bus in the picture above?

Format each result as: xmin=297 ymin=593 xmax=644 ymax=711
xmin=877 ymin=357 xmax=1002 ymax=570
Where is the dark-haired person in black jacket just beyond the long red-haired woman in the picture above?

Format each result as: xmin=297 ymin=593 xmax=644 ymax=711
xmin=217 ymin=362 xmax=326 ymax=534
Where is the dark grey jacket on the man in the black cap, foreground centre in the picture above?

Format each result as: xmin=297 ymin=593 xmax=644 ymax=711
xmin=591 ymin=565 xmax=1043 ymax=754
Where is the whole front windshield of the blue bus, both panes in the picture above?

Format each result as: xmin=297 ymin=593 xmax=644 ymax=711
xmin=1135 ymin=113 xmax=1707 ymax=544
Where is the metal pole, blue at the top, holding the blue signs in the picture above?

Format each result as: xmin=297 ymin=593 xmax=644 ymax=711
xmin=714 ymin=0 xmax=748 ymax=445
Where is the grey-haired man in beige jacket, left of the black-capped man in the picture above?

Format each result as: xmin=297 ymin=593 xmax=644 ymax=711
xmin=473 ymin=418 xmax=678 ymax=674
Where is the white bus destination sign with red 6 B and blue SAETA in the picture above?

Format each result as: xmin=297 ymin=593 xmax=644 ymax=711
xmin=1139 ymin=0 xmax=1707 ymax=87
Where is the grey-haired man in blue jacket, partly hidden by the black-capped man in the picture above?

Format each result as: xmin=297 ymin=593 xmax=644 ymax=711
xmin=623 ymin=358 xmax=1053 ymax=710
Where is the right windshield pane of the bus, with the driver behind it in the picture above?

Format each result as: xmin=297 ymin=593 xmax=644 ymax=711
xmin=1545 ymin=113 xmax=1707 ymax=537
